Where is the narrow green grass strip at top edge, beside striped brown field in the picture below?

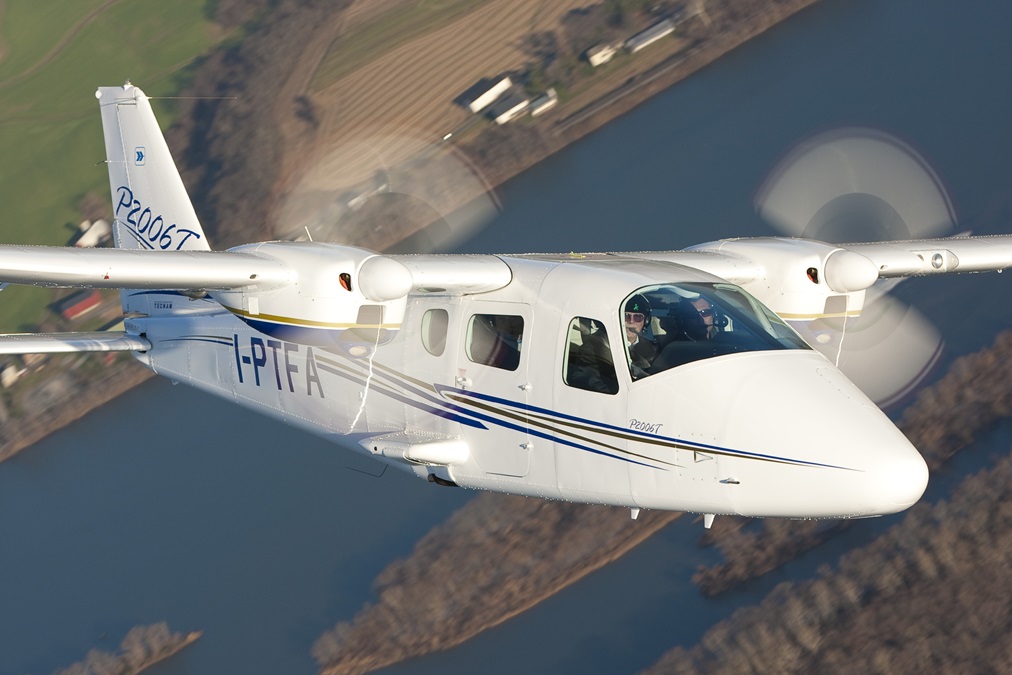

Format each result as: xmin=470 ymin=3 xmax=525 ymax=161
xmin=311 ymin=0 xmax=486 ymax=91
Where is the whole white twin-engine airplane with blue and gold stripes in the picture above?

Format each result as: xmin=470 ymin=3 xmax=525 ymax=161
xmin=0 ymin=83 xmax=1012 ymax=527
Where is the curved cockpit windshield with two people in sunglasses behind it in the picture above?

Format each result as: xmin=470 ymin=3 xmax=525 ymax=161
xmin=622 ymin=283 xmax=810 ymax=379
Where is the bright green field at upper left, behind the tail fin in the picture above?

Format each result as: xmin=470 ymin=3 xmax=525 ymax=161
xmin=0 ymin=0 xmax=226 ymax=332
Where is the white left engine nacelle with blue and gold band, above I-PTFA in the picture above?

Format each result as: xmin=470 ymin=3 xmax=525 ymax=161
xmin=210 ymin=242 xmax=412 ymax=355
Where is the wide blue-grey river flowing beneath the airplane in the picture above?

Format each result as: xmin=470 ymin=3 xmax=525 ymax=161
xmin=0 ymin=0 xmax=1012 ymax=674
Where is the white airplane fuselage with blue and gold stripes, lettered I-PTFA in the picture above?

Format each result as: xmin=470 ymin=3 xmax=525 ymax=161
xmin=124 ymin=256 xmax=927 ymax=517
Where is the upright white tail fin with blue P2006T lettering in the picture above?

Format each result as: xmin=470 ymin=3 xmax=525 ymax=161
xmin=95 ymin=82 xmax=210 ymax=251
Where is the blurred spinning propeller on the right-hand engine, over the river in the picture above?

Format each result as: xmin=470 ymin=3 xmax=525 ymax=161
xmin=755 ymin=129 xmax=956 ymax=407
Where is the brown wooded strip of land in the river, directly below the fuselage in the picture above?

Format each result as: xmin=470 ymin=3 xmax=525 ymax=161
xmin=313 ymin=494 xmax=681 ymax=675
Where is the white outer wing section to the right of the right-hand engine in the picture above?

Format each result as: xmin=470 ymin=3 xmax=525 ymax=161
xmin=840 ymin=235 xmax=1012 ymax=278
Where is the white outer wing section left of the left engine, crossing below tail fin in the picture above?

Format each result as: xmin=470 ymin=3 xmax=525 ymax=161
xmin=0 ymin=246 xmax=291 ymax=289
